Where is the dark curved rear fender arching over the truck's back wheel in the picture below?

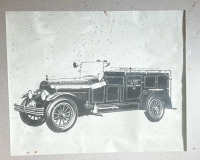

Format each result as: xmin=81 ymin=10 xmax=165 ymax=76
xmin=139 ymin=90 xmax=173 ymax=110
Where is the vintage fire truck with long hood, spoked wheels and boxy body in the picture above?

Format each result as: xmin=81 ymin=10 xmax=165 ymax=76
xmin=14 ymin=60 xmax=173 ymax=132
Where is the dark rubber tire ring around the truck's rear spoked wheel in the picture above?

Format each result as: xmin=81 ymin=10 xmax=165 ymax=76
xmin=144 ymin=94 xmax=166 ymax=122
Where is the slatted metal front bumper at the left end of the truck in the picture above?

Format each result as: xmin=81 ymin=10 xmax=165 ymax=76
xmin=14 ymin=104 xmax=44 ymax=116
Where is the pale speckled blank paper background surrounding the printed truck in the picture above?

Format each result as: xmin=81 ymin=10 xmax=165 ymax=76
xmin=6 ymin=11 xmax=183 ymax=156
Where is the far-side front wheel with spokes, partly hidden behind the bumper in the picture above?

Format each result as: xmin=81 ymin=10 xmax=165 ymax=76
xmin=19 ymin=99 xmax=45 ymax=127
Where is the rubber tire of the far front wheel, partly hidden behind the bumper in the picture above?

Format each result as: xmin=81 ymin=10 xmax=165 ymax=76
xmin=19 ymin=99 xmax=45 ymax=127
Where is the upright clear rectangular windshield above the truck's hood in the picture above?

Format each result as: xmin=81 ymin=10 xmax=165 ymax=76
xmin=81 ymin=62 xmax=103 ymax=77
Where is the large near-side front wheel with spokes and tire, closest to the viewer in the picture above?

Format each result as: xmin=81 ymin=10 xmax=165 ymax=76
xmin=46 ymin=98 xmax=78 ymax=132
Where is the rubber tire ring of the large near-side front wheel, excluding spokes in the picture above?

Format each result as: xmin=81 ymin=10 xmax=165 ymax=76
xmin=46 ymin=98 xmax=78 ymax=132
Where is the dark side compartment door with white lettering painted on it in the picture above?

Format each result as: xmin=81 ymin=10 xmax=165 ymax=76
xmin=126 ymin=75 xmax=142 ymax=100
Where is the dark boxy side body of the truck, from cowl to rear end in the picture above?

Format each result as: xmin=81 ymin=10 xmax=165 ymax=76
xmin=88 ymin=72 xmax=171 ymax=108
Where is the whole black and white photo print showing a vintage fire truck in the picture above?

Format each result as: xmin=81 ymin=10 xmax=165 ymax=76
xmin=6 ymin=10 xmax=184 ymax=156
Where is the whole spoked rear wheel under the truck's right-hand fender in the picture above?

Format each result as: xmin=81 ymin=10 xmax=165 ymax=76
xmin=145 ymin=95 xmax=165 ymax=122
